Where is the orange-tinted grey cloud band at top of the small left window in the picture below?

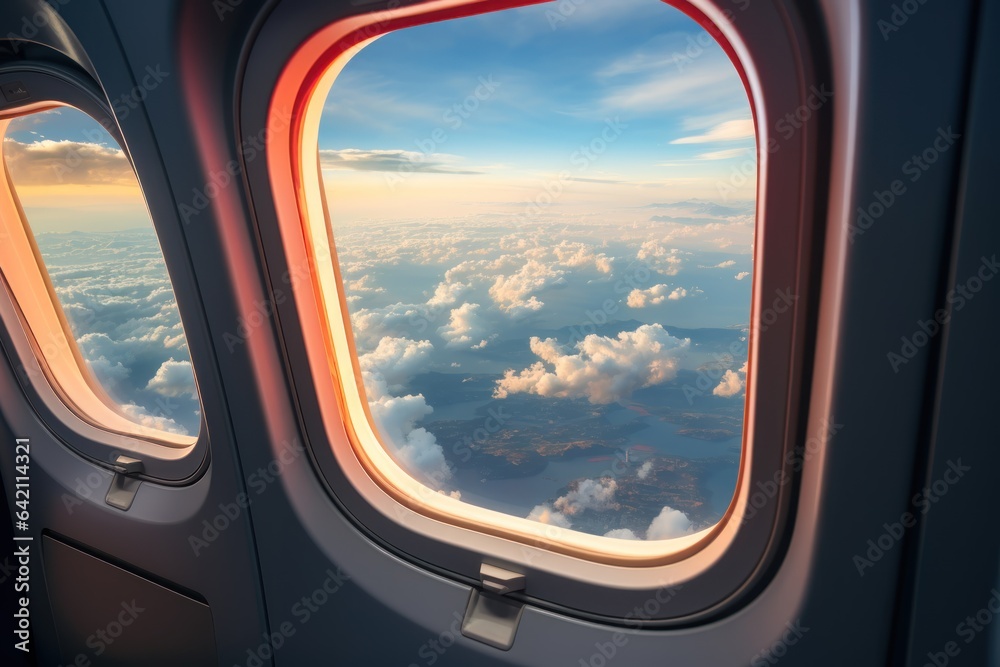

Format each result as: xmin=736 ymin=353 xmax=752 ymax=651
xmin=3 ymin=139 xmax=137 ymax=186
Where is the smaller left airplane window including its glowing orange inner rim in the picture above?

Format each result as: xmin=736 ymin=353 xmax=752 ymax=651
xmin=2 ymin=106 xmax=201 ymax=445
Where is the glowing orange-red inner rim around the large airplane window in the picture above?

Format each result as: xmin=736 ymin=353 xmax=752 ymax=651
xmin=267 ymin=0 xmax=753 ymax=566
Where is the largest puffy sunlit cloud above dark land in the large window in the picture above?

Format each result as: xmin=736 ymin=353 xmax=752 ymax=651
xmin=493 ymin=324 xmax=691 ymax=404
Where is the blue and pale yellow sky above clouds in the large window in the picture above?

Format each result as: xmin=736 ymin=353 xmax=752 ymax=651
xmin=319 ymin=0 xmax=755 ymax=224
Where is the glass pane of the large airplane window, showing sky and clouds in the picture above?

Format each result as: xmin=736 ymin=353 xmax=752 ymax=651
xmin=318 ymin=0 xmax=757 ymax=541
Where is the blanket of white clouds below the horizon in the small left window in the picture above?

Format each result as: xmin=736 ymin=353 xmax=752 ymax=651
xmin=29 ymin=231 xmax=201 ymax=435
